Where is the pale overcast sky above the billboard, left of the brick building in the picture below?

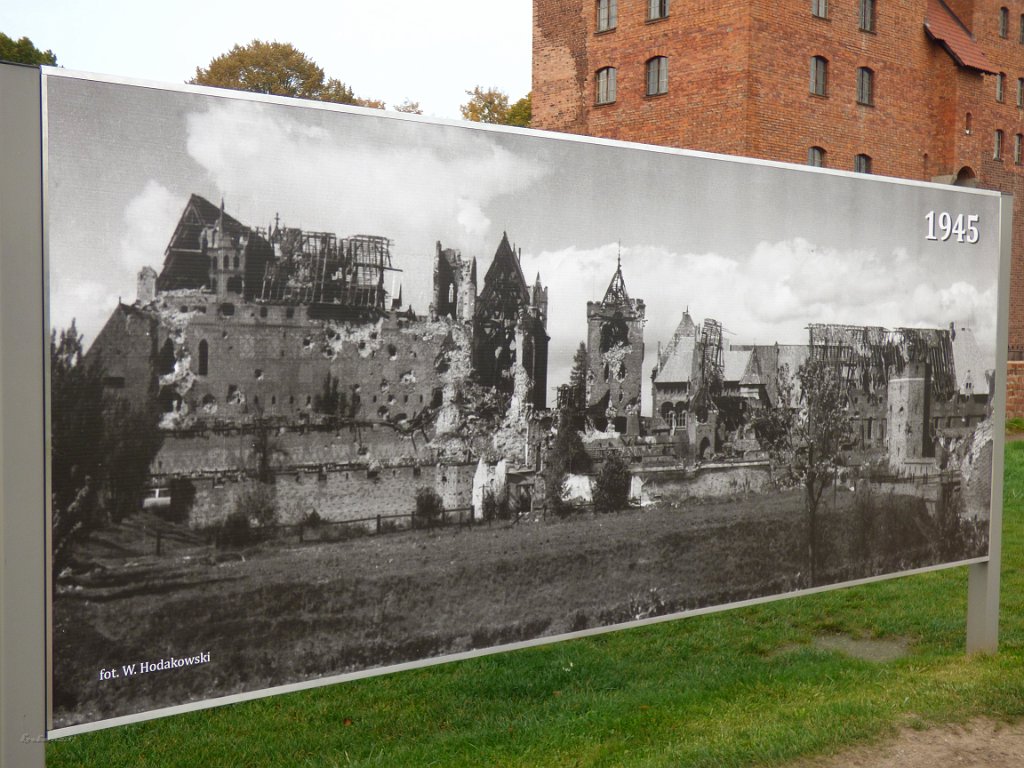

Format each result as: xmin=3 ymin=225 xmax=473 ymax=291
xmin=0 ymin=0 xmax=532 ymax=118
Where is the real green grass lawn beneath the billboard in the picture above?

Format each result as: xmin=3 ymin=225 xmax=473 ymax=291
xmin=46 ymin=442 xmax=1024 ymax=768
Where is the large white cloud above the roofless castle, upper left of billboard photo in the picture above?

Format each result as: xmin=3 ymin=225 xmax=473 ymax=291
xmin=187 ymin=101 xmax=548 ymax=310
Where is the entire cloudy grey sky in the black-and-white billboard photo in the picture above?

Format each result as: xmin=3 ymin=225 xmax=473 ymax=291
xmin=47 ymin=76 xmax=998 ymax=409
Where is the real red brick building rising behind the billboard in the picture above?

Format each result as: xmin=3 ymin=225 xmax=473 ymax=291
xmin=532 ymin=0 xmax=1024 ymax=357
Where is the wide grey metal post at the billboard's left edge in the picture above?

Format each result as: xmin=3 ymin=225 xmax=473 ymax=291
xmin=0 ymin=65 xmax=46 ymax=768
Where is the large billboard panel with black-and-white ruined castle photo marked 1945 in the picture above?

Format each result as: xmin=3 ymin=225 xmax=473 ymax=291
xmin=43 ymin=70 xmax=1006 ymax=735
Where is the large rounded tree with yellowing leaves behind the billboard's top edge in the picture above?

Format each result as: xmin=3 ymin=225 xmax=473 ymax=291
xmin=188 ymin=40 xmax=384 ymax=109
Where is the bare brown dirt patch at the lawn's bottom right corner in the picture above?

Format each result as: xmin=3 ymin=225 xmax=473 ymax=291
xmin=791 ymin=720 xmax=1024 ymax=768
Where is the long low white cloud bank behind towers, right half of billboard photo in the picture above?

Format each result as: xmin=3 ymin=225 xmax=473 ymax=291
xmin=522 ymin=239 xmax=995 ymax=412
